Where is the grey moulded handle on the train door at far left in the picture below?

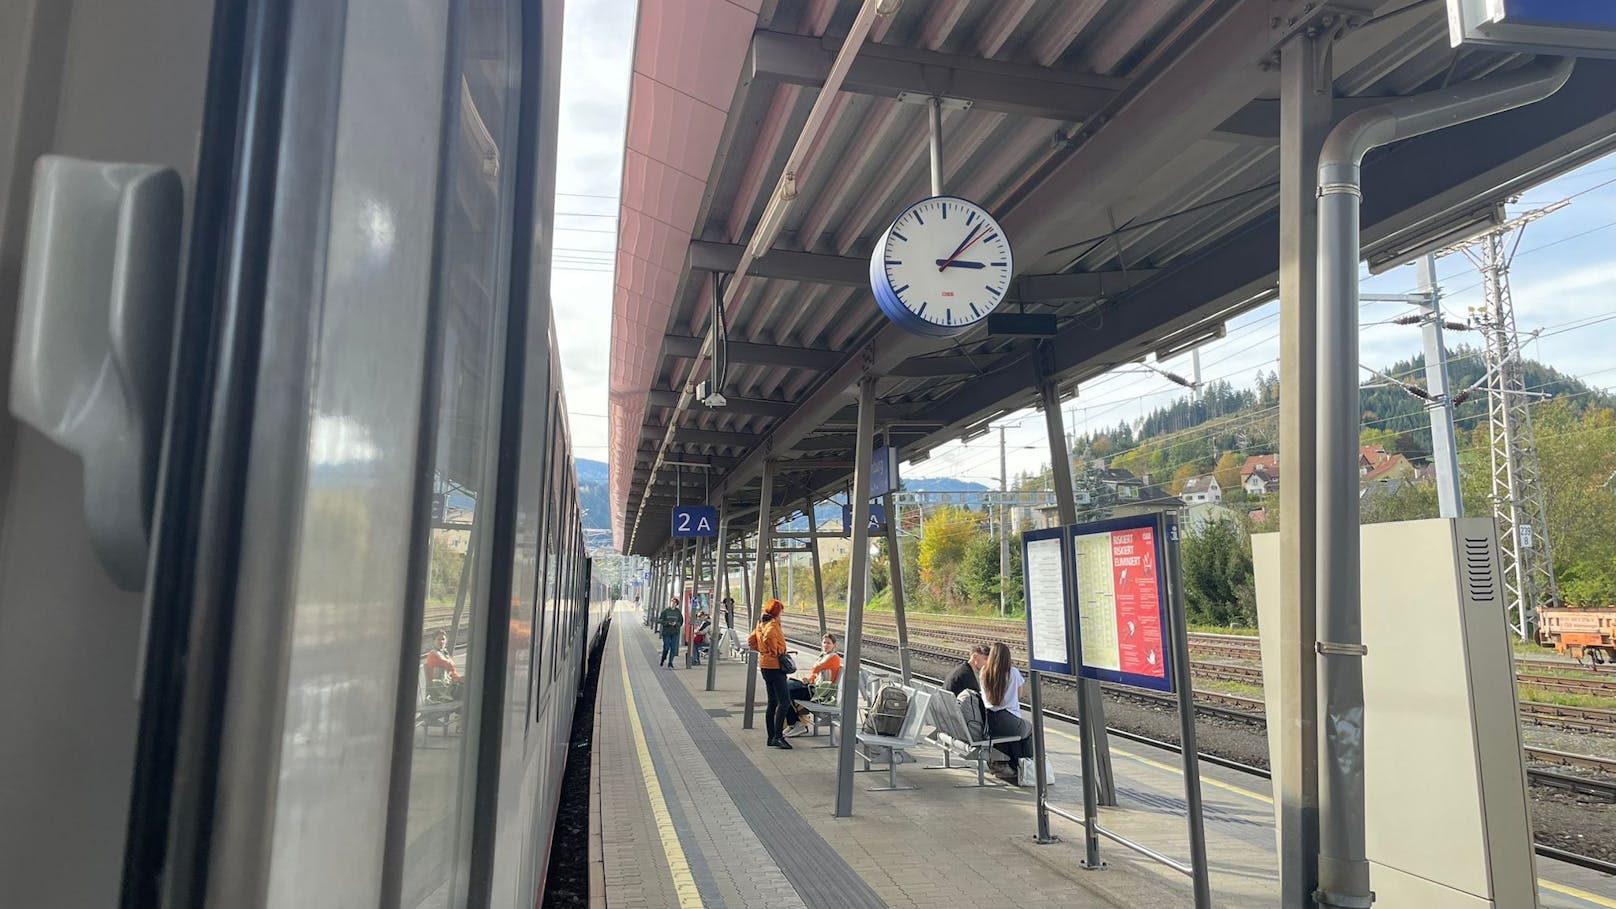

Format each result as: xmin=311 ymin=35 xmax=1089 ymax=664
xmin=11 ymin=155 xmax=184 ymax=590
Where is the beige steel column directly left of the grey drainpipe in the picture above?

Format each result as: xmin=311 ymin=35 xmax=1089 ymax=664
xmin=1269 ymin=34 xmax=1325 ymax=906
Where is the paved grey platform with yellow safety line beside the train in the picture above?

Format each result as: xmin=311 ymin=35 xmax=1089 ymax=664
xmin=590 ymin=601 xmax=1616 ymax=909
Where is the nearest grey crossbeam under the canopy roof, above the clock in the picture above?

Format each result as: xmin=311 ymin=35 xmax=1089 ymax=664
xmin=748 ymin=31 xmax=1126 ymax=123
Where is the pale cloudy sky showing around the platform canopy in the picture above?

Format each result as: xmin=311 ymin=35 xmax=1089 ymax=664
xmin=553 ymin=0 xmax=1616 ymax=485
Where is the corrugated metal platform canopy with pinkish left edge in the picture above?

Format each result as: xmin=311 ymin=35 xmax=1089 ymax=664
xmin=609 ymin=0 xmax=1616 ymax=553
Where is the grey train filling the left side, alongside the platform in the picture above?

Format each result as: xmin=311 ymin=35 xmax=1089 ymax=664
xmin=0 ymin=0 xmax=611 ymax=909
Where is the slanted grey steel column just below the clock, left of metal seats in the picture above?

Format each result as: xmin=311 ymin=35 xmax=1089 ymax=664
xmin=840 ymin=375 xmax=876 ymax=817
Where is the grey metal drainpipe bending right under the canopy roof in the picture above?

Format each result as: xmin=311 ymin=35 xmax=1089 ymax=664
xmin=1314 ymin=58 xmax=1572 ymax=909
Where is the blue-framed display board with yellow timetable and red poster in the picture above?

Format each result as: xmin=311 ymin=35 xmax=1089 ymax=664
xmin=1070 ymin=514 xmax=1173 ymax=691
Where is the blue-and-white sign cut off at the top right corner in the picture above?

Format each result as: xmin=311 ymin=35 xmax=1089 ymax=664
xmin=1448 ymin=0 xmax=1616 ymax=57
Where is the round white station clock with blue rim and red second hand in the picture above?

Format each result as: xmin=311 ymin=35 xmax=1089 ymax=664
xmin=869 ymin=196 xmax=1015 ymax=336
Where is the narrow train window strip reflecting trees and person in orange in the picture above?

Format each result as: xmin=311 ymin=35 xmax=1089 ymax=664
xmin=401 ymin=0 xmax=519 ymax=909
